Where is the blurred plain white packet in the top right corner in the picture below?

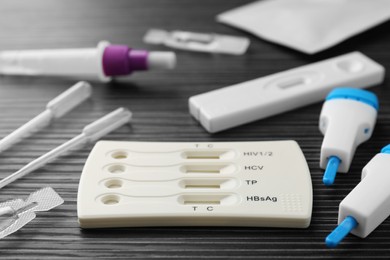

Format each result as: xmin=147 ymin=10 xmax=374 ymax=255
xmin=217 ymin=0 xmax=390 ymax=54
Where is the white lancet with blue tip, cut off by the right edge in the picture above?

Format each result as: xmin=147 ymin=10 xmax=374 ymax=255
xmin=325 ymin=145 xmax=390 ymax=248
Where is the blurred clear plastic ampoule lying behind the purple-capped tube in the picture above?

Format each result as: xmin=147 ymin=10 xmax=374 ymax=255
xmin=144 ymin=29 xmax=250 ymax=55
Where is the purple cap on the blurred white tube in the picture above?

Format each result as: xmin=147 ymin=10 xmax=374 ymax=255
xmin=102 ymin=45 xmax=148 ymax=76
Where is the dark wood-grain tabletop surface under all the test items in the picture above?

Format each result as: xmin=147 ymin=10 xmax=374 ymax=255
xmin=0 ymin=0 xmax=390 ymax=259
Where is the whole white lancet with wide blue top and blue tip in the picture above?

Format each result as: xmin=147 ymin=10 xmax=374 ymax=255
xmin=319 ymin=88 xmax=379 ymax=186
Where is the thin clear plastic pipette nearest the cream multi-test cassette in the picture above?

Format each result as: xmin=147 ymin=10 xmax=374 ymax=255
xmin=0 ymin=108 xmax=131 ymax=188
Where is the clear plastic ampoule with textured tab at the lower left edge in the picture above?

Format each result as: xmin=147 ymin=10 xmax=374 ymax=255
xmin=0 ymin=187 xmax=64 ymax=239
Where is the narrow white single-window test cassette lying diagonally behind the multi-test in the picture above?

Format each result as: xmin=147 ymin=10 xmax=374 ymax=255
xmin=189 ymin=52 xmax=385 ymax=133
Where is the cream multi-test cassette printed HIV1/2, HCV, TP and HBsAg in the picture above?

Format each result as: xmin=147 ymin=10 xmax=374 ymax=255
xmin=77 ymin=141 xmax=313 ymax=228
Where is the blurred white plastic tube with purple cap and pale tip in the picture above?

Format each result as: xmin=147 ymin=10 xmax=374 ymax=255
xmin=0 ymin=41 xmax=176 ymax=82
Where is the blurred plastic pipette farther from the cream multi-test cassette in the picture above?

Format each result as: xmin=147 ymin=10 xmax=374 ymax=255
xmin=0 ymin=81 xmax=92 ymax=153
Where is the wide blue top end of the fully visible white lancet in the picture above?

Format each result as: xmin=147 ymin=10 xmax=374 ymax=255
xmin=326 ymin=88 xmax=379 ymax=110
